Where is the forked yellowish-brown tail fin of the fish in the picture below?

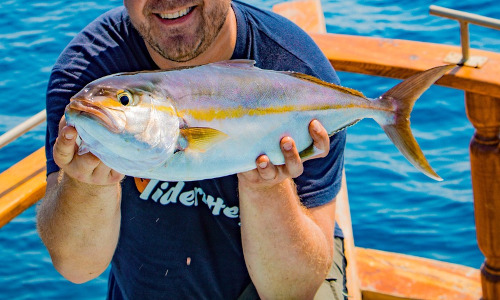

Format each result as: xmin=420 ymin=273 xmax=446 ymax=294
xmin=378 ymin=65 xmax=456 ymax=181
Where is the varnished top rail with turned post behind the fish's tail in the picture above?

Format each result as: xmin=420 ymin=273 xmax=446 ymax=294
xmin=312 ymin=17 xmax=500 ymax=299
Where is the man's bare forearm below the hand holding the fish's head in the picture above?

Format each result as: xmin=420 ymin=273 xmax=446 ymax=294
xmin=37 ymin=174 xmax=121 ymax=283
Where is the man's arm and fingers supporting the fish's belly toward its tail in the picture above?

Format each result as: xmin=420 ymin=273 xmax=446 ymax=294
xmin=238 ymin=121 xmax=335 ymax=299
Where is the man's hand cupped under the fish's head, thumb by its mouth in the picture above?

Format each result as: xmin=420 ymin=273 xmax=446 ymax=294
xmin=53 ymin=117 xmax=124 ymax=185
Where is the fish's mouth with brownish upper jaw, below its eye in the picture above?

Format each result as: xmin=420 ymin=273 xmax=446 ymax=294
xmin=66 ymin=98 xmax=126 ymax=133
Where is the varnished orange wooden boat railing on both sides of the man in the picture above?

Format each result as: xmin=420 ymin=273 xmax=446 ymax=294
xmin=0 ymin=0 xmax=500 ymax=299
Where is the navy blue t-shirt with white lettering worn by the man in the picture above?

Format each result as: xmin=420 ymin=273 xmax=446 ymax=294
xmin=46 ymin=1 xmax=345 ymax=299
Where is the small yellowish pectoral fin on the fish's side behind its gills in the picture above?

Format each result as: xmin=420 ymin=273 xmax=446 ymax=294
xmin=180 ymin=127 xmax=228 ymax=152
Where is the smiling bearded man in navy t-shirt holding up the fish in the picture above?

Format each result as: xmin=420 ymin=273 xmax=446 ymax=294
xmin=38 ymin=0 xmax=345 ymax=299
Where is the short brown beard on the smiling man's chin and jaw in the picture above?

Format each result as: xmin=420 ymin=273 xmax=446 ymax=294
xmin=134 ymin=4 xmax=229 ymax=62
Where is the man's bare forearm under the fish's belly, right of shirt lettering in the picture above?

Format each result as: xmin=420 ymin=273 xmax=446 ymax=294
xmin=239 ymin=179 xmax=333 ymax=299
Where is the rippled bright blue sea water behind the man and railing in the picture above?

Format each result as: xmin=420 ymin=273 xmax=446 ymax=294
xmin=0 ymin=0 xmax=500 ymax=299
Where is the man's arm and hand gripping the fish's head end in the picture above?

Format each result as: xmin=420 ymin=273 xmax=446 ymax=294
xmin=37 ymin=117 xmax=123 ymax=283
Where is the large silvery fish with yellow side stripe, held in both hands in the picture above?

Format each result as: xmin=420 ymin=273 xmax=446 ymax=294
xmin=65 ymin=60 xmax=456 ymax=181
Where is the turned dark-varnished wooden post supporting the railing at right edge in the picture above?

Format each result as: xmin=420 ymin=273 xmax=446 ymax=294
xmin=465 ymin=92 xmax=500 ymax=300
